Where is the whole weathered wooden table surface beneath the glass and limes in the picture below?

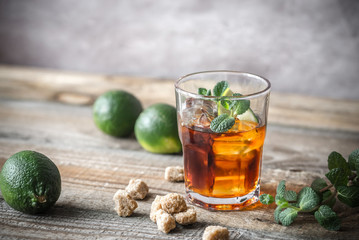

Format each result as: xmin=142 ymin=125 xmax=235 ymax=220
xmin=0 ymin=65 xmax=359 ymax=239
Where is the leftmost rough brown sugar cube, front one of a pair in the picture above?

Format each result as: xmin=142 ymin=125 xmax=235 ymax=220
xmin=113 ymin=190 xmax=137 ymax=217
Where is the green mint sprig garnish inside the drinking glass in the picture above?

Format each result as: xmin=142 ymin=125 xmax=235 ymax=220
xmin=198 ymin=81 xmax=250 ymax=133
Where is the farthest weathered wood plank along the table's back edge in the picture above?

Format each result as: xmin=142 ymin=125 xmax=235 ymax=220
xmin=0 ymin=65 xmax=359 ymax=133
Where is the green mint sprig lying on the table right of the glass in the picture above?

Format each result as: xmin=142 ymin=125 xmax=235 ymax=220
xmin=259 ymin=149 xmax=359 ymax=231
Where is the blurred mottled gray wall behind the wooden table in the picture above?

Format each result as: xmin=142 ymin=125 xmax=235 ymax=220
xmin=0 ymin=0 xmax=359 ymax=99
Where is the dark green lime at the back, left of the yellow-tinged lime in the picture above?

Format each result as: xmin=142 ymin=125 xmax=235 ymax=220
xmin=93 ymin=90 xmax=142 ymax=137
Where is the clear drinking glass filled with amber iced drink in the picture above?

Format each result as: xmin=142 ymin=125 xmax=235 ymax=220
xmin=175 ymin=71 xmax=271 ymax=210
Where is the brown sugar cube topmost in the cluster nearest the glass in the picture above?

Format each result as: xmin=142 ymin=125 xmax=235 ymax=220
xmin=160 ymin=193 xmax=187 ymax=214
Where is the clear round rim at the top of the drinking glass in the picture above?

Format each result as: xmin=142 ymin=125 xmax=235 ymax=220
xmin=175 ymin=70 xmax=271 ymax=99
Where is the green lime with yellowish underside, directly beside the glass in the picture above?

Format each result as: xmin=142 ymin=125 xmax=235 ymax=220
xmin=135 ymin=103 xmax=182 ymax=153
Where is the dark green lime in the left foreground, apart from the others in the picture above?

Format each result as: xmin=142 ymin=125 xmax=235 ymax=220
xmin=0 ymin=150 xmax=61 ymax=214
